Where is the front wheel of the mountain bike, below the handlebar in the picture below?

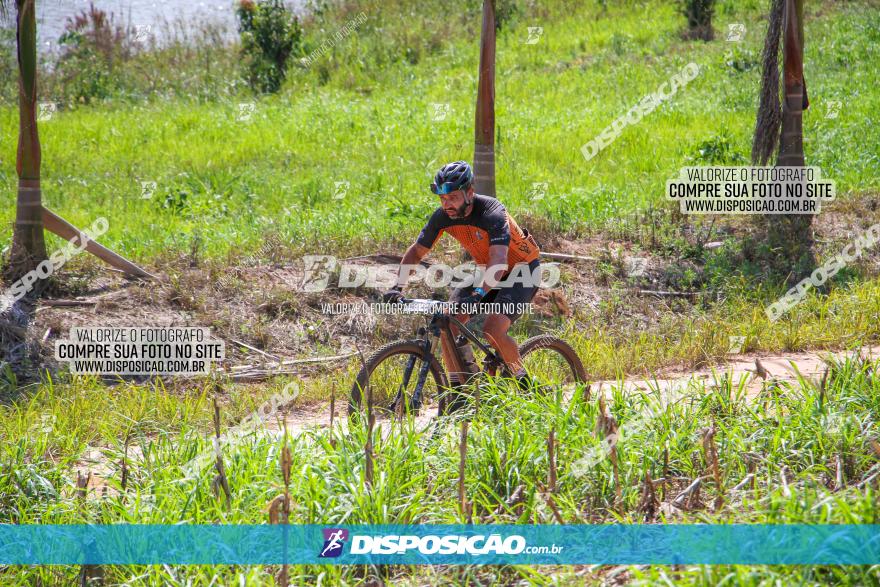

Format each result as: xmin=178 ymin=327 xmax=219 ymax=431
xmin=348 ymin=340 xmax=447 ymax=415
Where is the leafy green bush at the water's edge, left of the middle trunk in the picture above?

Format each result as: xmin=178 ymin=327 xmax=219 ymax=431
xmin=236 ymin=0 xmax=302 ymax=92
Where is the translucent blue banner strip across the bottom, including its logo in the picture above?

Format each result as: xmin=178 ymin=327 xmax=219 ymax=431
xmin=0 ymin=524 xmax=880 ymax=565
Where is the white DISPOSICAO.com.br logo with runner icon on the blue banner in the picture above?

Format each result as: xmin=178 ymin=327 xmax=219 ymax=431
xmin=320 ymin=528 xmax=563 ymax=557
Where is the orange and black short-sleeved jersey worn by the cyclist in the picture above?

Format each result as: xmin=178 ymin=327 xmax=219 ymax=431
xmin=416 ymin=194 xmax=539 ymax=271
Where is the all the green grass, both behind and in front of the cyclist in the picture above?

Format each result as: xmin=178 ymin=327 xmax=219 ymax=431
xmin=0 ymin=1 xmax=880 ymax=585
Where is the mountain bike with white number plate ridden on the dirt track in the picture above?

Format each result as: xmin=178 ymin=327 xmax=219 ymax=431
xmin=349 ymin=299 xmax=587 ymax=415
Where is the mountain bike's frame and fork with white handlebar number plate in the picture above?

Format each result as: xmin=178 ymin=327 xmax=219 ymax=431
xmin=389 ymin=299 xmax=507 ymax=411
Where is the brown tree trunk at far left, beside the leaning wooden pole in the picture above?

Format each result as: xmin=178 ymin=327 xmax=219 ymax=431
xmin=9 ymin=0 xmax=47 ymax=281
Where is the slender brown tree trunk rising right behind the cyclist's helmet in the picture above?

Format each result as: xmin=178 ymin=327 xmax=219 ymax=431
xmin=474 ymin=0 xmax=495 ymax=198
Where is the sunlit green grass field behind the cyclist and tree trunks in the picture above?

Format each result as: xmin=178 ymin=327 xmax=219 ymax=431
xmin=0 ymin=2 xmax=880 ymax=262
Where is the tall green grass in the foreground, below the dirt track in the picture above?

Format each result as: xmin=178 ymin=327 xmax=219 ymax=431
xmin=0 ymin=359 xmax=880 ymax=584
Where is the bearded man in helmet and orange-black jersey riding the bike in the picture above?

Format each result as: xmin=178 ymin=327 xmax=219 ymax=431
xmin=382 ymin=161 xmax=540 ymax=387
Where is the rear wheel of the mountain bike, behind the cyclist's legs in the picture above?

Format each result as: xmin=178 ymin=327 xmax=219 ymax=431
xmin=519 ymin=334 xmax=587 ymax=388
